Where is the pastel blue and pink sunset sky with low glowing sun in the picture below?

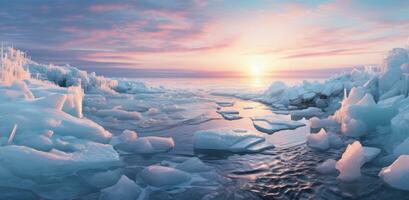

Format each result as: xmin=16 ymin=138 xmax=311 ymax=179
xmin=0 ymin=0 xmax=409 ymax=76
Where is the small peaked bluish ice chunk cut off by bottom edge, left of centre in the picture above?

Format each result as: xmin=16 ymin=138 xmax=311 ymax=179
xmin=99 ymin=175 xmax=141 ymax=200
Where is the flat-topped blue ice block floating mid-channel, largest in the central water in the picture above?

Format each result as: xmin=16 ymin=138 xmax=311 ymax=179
xmin=193 ymin=129 xmax=272 ymax=152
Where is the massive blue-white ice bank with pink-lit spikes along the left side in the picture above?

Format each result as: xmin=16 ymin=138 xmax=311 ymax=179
xmin=0 ymin=48 xmax=140 ymax=199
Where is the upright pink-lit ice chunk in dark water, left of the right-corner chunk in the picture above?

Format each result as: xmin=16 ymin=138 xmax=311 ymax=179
xmin=336 ymin=141 xmax=365 ymax=181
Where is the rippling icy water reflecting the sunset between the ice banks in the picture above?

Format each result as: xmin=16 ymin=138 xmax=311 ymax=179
xmin=84 ymin=85 xmax=409 ymax=199
